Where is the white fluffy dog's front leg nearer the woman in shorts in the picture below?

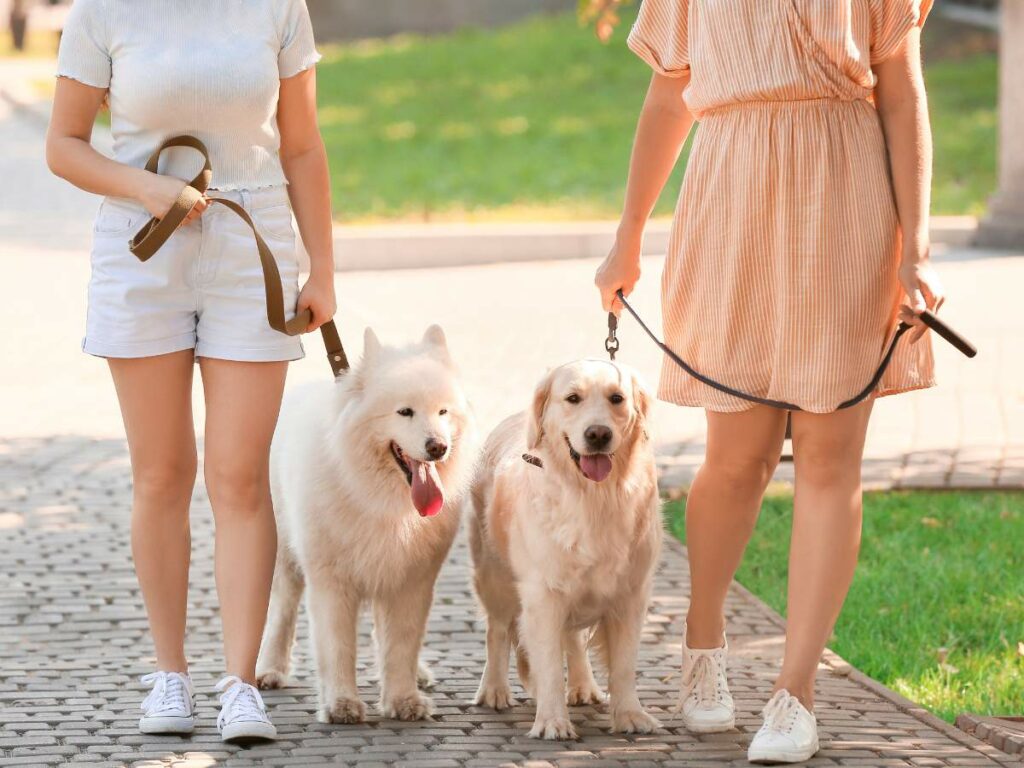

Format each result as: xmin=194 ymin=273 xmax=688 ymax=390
xmin=307 ymin=574 xmax=367 ymax=723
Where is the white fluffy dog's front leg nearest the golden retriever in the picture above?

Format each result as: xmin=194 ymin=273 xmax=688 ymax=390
xmin=374 ymin=573 xmax=436 ymax=720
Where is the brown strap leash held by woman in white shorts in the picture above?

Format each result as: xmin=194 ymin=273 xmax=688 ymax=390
xmin=129 ymin=136 xmax=348 ymax=378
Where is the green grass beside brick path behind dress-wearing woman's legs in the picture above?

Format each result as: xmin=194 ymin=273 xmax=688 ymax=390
xmin=668 ymin=493 xmax=1024 ymax=721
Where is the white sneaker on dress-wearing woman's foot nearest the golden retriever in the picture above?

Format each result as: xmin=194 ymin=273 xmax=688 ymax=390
xmin=678 ymin=629 xmax=736 ymax=733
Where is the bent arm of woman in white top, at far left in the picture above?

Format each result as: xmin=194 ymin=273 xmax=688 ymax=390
xmin=46 ymin=78 xmax=207 ymax=225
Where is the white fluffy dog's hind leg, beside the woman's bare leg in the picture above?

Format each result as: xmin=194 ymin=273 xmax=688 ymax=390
xmin=256 ymin=542 xmax=304 ymax=688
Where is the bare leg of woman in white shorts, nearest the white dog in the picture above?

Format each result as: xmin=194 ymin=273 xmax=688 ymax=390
xmin=200 ymin=357 xmax=288 ymax=684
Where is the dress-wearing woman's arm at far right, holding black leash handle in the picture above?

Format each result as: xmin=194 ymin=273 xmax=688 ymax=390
xmin=874 ymin=29 xmax=943 ymax=340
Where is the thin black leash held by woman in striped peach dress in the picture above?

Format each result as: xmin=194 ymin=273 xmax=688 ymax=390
xmin=604 ymin=290 xmax=978 ymax=411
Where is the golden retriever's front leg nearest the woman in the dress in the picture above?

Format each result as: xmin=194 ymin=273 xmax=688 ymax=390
xmin=601 ymin=606 xmax=659 ymax=733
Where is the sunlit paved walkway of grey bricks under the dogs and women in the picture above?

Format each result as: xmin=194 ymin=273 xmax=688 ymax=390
xmin=0 ymin=66 xmax=1024 ymax=766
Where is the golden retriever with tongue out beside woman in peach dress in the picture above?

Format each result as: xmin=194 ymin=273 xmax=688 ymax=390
xmin=470 ymin=360 xmax=662 ymax=739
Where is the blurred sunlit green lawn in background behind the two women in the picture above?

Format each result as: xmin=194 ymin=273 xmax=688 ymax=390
xmin=318 ymin=11 xmax=996 ymax=221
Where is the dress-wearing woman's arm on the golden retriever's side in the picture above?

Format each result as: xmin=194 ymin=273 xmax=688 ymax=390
xmin=594 ymin=73 xmax=693 ymax=313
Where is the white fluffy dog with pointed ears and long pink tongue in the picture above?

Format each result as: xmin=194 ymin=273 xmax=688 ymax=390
xmin=257 ymin=326 xmax=475 ymax=723
